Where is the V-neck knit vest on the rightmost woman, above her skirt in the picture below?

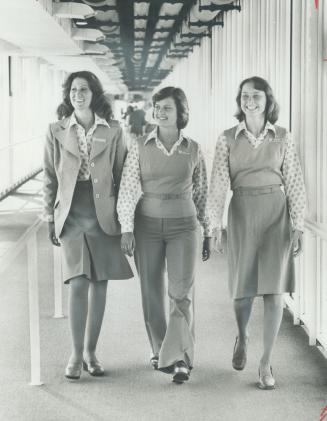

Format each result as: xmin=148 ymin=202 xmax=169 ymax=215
xmin=224 ymin=126 xmax=286 ymax=190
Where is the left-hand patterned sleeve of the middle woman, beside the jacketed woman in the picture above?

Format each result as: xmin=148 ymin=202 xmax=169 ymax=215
xmin=117 ymin=140 xmax=141 ymax=233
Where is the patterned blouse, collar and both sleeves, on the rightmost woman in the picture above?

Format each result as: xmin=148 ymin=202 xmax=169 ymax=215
xmin=208 ymin=121 xmax=306 ymax=231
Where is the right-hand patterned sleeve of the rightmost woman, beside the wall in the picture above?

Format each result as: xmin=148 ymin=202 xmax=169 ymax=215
xmin=282 ymin=133 xmax=306 ymax=231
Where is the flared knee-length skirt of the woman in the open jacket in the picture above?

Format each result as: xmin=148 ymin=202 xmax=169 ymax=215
xmin=59 ymin=181 xmax=133 ymax=283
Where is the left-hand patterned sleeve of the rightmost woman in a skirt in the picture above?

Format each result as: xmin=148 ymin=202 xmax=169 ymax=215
xmin=208 ymin=134 xmax=230 ymax=230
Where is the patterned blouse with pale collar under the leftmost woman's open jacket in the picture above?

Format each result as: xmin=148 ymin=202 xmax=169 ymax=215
xmin=69 ymin=113 xmax=109 ymax=181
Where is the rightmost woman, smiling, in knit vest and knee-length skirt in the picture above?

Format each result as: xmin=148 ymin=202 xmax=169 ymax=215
xmin=209 ymin=77 xmax=305 ymax=389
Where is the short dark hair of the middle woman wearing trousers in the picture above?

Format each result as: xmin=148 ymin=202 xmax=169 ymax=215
xmin=152 ymin=86 xmax=189 ymax=130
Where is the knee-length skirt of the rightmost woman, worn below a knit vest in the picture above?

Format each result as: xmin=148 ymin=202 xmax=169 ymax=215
xmin=227 ymin=186 xmax=295 ymax=299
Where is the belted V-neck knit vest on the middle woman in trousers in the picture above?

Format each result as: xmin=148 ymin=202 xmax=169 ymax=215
xmin=136 ymin=137 xmax=199 ymax=218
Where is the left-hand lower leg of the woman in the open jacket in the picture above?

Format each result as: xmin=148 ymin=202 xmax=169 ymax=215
xmin=68 ymin=276 xmax=89 ymax=364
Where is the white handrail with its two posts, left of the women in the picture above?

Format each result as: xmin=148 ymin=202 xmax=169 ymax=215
xmin=0 ymin=220 xmax=64 ymax=386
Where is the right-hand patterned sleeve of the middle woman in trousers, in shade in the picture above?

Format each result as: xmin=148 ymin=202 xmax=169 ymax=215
xmin=192 ymin=148 xmax=211 ymax=237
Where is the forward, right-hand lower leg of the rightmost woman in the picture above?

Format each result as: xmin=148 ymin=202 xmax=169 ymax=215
xmin=260 ymin=294 xmax=283 ymax=374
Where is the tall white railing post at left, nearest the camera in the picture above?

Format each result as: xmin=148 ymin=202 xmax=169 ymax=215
xmin=27 ymin=233 xmax=43 ymax=386
